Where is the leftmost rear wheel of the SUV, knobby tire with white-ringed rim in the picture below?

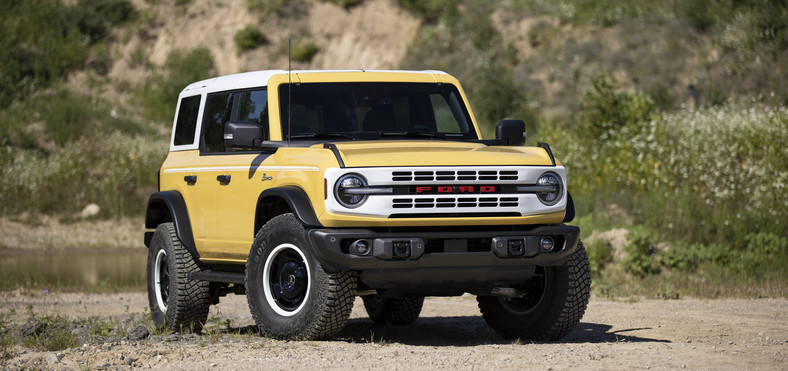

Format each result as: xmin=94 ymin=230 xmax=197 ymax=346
xmin=147 ymin=223 xmax=211 ymax=333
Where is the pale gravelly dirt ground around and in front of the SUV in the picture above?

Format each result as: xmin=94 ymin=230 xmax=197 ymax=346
xmin=0 ymin=292 xmax=788 ymax=370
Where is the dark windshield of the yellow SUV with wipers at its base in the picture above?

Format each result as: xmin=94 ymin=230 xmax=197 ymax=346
xmin=279 ymin=82 xmax=478 ymax=139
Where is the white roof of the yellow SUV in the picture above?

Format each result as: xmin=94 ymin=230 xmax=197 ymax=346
xmin=183 ymin=70 xmax=447 ymax=92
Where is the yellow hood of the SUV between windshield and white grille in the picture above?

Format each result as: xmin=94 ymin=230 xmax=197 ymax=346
xmin=334 ymin=140 xmax=552 ymax=167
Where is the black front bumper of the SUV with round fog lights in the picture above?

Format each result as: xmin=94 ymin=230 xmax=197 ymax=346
xmin=307 ymin=225 xmax=580 ymax=295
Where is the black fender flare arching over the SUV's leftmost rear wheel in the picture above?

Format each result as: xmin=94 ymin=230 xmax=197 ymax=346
xmin=145 ymin=191 xmax=200 ymax=259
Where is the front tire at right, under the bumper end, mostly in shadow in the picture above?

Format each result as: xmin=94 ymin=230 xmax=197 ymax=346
xmin=476 ymin=242 xmax=591 ymax=341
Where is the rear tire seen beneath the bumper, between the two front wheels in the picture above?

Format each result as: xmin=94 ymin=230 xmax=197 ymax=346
xmin=363 ymin=295 xmax=424 ymax=326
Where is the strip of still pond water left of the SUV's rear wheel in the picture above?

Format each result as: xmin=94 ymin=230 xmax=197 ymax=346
xmin=0 ymin=248 xmax=147 ymax=291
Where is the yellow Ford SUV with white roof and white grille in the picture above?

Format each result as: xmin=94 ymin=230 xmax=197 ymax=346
xmin=145 ymin=70 xmax=591 ymax=340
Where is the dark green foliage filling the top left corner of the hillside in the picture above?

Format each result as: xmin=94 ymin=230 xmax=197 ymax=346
xmin=0 ymin=0 xmax=136 ymax=106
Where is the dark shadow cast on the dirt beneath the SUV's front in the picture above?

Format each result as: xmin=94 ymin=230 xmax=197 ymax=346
xmin=335 ymin=316 xmax=670 ymax=346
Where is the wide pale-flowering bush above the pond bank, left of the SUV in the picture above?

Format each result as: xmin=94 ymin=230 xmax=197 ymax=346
xmin=0 ymin=133 xmax=167 ymax=217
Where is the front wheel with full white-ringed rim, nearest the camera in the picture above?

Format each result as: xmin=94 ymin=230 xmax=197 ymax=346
xmin=246 ymin=214 xmax=355 ymax=340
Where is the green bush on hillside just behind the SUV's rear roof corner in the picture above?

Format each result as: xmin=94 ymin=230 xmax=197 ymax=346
xmin=140 ymin=48 xmax=216 ymax=124
